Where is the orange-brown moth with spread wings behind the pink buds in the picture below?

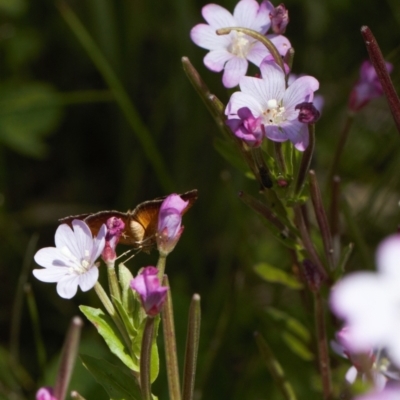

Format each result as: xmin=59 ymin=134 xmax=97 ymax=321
xmin=59 ymin=189 xmax=198 ymax=251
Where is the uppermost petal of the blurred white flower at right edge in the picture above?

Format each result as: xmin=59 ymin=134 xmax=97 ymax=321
xmin=376 ymin=234 xmax=400 ymax=278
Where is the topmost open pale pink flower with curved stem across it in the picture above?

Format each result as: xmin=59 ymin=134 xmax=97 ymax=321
xmin=190 ymin=0 xmax=291 ymax=88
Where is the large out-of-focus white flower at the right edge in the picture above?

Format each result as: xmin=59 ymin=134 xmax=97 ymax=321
xmin=330 ymin=234 xmax=400 ymax=367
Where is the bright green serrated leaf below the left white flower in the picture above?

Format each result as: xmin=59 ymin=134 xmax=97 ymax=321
xmin=79 ymin=306 xmax=139 ymax=371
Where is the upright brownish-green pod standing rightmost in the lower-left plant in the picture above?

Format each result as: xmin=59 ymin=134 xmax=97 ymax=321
xmin=182 ymin=294 xmax=201 ymax=400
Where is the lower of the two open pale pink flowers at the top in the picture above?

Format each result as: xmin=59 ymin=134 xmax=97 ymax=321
xmin=225 ymin=61 xmax=319 ymax=151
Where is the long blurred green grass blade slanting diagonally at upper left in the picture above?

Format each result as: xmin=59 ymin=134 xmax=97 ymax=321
xmin=58 ymin=0 xmax=173 ymax=192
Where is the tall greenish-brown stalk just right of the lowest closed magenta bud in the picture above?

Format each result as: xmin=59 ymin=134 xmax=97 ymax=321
xmin=161 ymin=275 xmax=181 ymax=400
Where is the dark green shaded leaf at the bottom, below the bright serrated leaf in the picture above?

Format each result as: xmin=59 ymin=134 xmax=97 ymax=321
xmin=80 ymin=354 xmax=142 ymax=400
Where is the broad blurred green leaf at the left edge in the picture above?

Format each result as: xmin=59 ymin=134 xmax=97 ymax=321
xmin=0 ymin=82 xmax=61 ymax=157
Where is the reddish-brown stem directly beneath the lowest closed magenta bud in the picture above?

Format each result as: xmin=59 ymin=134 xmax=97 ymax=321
xmin=140 ymin=317 xmax=154 ymax=400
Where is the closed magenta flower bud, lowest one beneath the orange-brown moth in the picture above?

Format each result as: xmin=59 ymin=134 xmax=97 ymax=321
xmin=131 ymin=267 xmax=168 ymax=317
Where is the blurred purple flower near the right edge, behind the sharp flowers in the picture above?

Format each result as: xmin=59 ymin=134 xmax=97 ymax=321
xmin=349 ymin=60 xmax=393 ymax=112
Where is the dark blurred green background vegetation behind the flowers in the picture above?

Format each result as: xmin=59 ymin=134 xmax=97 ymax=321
xmin=0 ymin=0 xmax=400 ymax=400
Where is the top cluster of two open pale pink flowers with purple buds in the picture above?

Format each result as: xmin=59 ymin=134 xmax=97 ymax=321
xmin=191 ymin=0 xmax=319 ymax=151
